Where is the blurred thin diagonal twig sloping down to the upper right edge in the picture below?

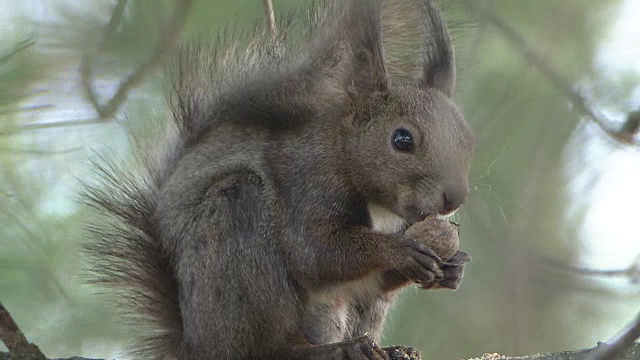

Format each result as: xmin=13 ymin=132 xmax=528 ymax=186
xmin=465 ymin=0 xmax=639 ymax=145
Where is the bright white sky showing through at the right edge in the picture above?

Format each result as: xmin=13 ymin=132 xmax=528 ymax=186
xmin=566 ymin=0 xmax=640 ymax=270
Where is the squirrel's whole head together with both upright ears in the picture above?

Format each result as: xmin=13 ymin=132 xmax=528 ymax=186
xmin=332 ymin=0 xmax=473 ymax=223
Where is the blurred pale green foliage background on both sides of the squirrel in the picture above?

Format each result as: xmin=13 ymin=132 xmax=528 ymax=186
xmin=0 ymin=0 xmax=639 ymax=359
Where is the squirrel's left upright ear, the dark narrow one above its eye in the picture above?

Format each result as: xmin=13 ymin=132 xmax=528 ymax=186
xmin=339 ymin=0 xmax=388 ymax=98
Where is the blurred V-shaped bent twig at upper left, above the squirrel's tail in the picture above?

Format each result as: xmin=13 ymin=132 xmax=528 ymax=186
xmin=80 ymin=0 xmax=192 ymax=120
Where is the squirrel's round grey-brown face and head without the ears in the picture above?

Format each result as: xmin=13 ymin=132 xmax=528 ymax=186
xmin=345 ymin=85 xmax=473 ymax=223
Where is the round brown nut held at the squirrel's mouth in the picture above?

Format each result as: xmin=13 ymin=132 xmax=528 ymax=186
xmin=404 ymin=217 xmax=460 ymax=260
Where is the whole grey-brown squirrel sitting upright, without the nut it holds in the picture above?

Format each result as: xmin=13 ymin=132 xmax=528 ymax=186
xmin=87 ymin=0 xmax=473 ymax=360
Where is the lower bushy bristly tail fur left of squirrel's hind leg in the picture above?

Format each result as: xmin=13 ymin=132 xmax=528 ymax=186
xmin=83 ymin=127 xmax=183 ymax=359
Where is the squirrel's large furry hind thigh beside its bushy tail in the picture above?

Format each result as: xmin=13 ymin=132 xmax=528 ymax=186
xmin=178 ymin=169 xmax=300 ymax=360
